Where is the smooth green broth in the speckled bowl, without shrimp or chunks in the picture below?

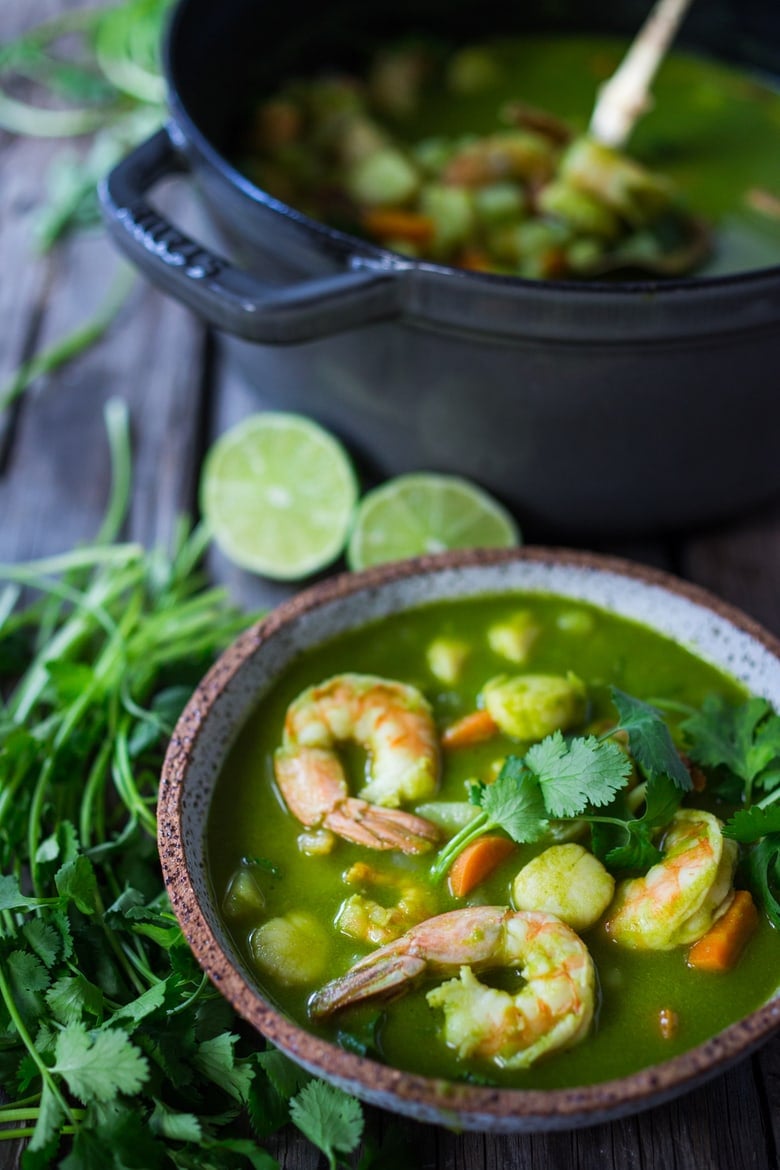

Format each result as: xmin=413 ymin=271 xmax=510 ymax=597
xmin=208 ymin=594 xmax=780 ymax=1087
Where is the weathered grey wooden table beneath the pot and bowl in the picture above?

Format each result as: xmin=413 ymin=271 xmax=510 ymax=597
xmin=0 ymin=0 xmax=780 ymax=1170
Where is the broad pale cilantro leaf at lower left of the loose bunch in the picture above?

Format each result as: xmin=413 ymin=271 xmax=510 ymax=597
xmin=51 ymin=1024 xmax=149 ymax=1102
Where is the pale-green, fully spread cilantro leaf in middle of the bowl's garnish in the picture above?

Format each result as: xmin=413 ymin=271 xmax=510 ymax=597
xmin=525 ymin=731 xmax=631 ymax=820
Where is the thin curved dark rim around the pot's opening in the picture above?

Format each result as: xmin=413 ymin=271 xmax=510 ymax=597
xmin=163 ymin=0 xmax=780 ymax=301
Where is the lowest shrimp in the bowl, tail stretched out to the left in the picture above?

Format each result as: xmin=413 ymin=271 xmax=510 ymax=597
xmin=309 ymin=906 xmax=595 ymax=1068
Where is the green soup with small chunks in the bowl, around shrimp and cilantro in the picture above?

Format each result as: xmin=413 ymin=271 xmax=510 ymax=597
xmin=208 ymin=594 xmax=780 ymax=1087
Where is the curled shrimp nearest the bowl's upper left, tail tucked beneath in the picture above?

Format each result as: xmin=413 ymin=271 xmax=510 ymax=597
xmin=274 ymin=674 xmax=439 ymax=853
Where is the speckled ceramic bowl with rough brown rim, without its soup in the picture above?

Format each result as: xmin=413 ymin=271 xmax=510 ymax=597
xmin=159 ymin=549 xmax=780 ymax=1133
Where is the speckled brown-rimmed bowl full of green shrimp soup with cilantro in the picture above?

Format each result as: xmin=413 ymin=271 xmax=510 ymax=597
xmin=159 ymin=549 xmax=780 ymax=1131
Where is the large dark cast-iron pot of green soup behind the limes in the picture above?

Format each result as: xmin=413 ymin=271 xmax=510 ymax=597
xmin=102 ymin=0 xmax=780 ymax=541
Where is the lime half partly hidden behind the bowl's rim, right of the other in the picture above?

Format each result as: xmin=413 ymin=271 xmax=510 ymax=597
xmin=347 ymin=472 xmax=520 ymax=569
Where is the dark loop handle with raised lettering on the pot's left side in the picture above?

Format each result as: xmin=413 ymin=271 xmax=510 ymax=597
xmin=98 ymin=129 xmax=401 ymax=345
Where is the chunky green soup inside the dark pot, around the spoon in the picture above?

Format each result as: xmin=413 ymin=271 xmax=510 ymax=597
xmin=239 ymin=36 xmax=780 ymax=278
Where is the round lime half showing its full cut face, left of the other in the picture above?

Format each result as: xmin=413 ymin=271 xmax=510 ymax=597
xmin=200 ymin=411 xmax=358 ymax=580
